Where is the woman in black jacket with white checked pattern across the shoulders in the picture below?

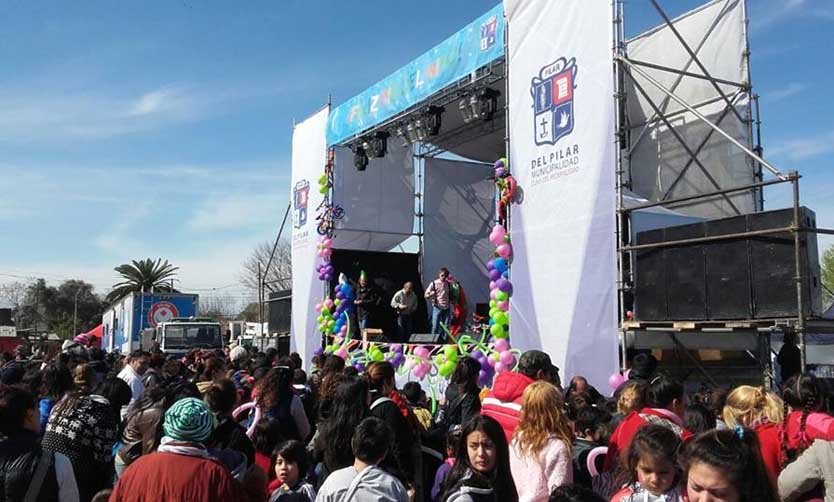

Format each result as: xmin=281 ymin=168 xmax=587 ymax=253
xmin=42 ymin=386 xmax=119 ymax=502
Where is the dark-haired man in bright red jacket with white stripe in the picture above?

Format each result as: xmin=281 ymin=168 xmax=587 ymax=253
xmin=481 ymin=350 xmax=562 ymax=441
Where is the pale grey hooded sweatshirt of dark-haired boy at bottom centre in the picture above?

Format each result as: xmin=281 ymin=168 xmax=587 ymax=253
xmin=316 ymin=465 xmax=408 ymax=502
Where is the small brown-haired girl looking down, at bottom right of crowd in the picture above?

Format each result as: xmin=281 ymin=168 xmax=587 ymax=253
xmin=611 ymin=425 xmax=683 ymax=502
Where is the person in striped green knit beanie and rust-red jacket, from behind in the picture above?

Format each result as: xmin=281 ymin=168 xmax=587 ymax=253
xmin=110 ymin=397 xmax=250 ymax=502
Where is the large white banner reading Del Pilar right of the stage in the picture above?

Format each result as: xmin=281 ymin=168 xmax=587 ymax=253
xmin=504 ymin=0 xmax=618 ymax=391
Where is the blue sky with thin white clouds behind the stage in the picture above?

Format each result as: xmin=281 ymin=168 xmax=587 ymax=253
xmin=0 ymin=0 xmax=834 ymax=301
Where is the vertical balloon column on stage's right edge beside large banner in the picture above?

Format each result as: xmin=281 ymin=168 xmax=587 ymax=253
xmin=487 ymin=224 xmax=513 ymax=339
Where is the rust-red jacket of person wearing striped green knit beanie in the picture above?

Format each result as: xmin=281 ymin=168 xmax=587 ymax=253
xmin=110 ymin=452 xmax=248 ymax=502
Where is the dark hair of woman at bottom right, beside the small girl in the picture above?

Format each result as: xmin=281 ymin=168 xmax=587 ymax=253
xmin=682 ymin=429 xmax=778 ymax=502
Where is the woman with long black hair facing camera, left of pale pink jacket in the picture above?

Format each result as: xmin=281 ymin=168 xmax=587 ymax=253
xmin=441 ymin=415 xmax=516 ymax=502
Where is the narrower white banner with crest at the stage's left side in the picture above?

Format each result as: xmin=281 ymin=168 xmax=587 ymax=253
xmin=290 ymin=107 xmax=330 ymax=365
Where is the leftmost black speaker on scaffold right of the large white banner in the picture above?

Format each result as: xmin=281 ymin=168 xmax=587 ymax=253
xmin=634 ymin=228 xmax=669 ymax=320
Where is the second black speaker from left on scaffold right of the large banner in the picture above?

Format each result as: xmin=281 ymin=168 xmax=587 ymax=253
xmin=665 ymin=223 xmax=707 ymax=321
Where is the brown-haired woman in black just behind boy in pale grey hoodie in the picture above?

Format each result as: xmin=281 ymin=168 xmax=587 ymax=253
xmin=365 ymin=361 xmax=417 ymax=486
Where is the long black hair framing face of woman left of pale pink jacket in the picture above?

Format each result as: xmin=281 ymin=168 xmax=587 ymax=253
xmin=441 ymin=415 xmax=518 ymax=502
